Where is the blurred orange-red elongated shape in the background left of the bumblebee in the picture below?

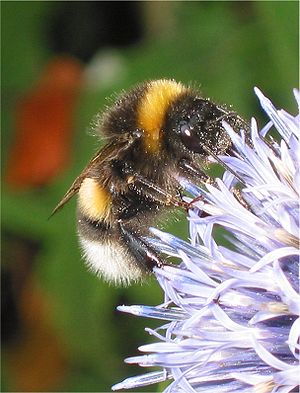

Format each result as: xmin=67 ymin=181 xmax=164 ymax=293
xmin=6 ymin=57 xmax=83 ymax=189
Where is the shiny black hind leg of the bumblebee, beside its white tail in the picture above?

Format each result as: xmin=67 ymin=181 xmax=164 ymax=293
xmin=119 ymin=221 xmax=164 ymax=270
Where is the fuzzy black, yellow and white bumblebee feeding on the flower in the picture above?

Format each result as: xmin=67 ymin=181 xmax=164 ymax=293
xmin=53 ymin=79 xmax=242 ymax=285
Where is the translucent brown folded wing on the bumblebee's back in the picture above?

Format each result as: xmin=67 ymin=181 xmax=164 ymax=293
xmin=49 ymin=134 xmax=137 ymax=218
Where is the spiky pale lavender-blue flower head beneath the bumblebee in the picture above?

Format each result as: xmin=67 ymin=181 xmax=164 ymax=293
xmin=113 ymin=88 xmax=300 ymax=393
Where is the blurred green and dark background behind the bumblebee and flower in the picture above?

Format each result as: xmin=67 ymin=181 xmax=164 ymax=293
xmin=1 ymin=1 xmax=298 ymax=392
